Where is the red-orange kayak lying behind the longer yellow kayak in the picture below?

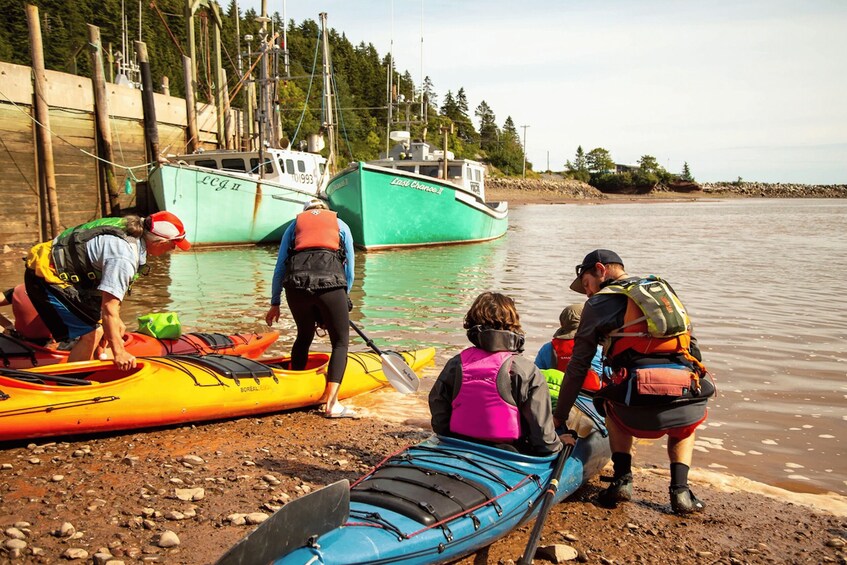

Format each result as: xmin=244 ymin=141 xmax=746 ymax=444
xmin=0 ymin=332 xmax=279 ymax=369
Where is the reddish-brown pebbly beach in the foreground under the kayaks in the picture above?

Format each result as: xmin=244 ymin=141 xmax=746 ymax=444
xmin=0 ymin=410 xmax=847 ymax=565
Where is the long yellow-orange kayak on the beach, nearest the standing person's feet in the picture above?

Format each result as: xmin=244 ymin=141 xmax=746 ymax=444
xmin=0 ymin=347 xmax=435 ymax=441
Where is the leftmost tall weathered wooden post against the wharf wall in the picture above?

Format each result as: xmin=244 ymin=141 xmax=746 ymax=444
xmin=26 ymin=4 xmax=62 ymax=238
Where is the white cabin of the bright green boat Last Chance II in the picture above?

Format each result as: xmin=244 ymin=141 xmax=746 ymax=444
xmin=369 ymin=141 xmax=485 ymax=200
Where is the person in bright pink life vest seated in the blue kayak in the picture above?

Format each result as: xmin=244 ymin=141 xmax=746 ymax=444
xmin=429 ymin=292 xmax=562 ymax=455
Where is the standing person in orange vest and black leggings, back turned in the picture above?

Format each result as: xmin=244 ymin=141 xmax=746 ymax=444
xmin=265 ymin=199 xmax=355 ymax=418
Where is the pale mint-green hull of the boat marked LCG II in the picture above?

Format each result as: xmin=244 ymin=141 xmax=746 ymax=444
xmin=149 ymin=163 xmax=315 ymax=246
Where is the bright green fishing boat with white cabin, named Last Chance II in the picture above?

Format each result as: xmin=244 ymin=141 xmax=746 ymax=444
xmin=326 ymin=134 xmax=509 ymax=250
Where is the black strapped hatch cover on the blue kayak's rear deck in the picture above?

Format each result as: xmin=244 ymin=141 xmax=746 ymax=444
xmin=350 ymin=464 xmax=494 ymax=526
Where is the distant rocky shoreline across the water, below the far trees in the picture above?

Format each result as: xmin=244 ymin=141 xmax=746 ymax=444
xmin=486 ymin=176 xmax=847 ymax=203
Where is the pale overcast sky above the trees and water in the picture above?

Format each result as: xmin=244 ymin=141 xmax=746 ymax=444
xmin=238 ymin=0 xmax=847 ymax=184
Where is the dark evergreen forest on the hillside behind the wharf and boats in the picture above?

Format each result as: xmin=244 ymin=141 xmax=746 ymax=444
xmin=0 ymin=0 xmax=532 ymax=175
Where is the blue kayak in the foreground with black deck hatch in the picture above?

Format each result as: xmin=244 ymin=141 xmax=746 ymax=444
xmin=272 ymin=408 xmax=610 ymax=565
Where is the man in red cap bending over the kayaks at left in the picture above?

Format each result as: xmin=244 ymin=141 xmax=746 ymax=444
xmin=24 ymin=211 xmax=191 ymax=371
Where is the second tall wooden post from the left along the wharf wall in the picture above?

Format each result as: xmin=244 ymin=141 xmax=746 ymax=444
xmin=88 ymin=24 xmax=121 ymax=216
